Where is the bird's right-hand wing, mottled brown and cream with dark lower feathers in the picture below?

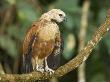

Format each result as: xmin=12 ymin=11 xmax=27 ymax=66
xmin=47 ymin=32 xmax=64 ymax=69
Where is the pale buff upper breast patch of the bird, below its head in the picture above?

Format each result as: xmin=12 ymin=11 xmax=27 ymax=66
xmin=39 ymin=22 xmax=59 ymax=41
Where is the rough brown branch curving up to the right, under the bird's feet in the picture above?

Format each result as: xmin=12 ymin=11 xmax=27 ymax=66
xmin=0 ymin=10 xmax=110 ymax=82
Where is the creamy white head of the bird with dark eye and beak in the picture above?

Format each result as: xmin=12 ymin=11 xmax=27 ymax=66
xmin=40 ymin=9 xmax=66 ymax=23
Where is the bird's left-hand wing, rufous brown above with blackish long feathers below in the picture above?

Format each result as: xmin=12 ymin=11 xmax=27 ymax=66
xmin=21 ymin=24 xmax=38 ymax=73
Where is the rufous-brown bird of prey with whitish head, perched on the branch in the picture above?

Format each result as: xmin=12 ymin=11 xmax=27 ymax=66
xmin=22 ymin=9 xmax=66 ymax=73
